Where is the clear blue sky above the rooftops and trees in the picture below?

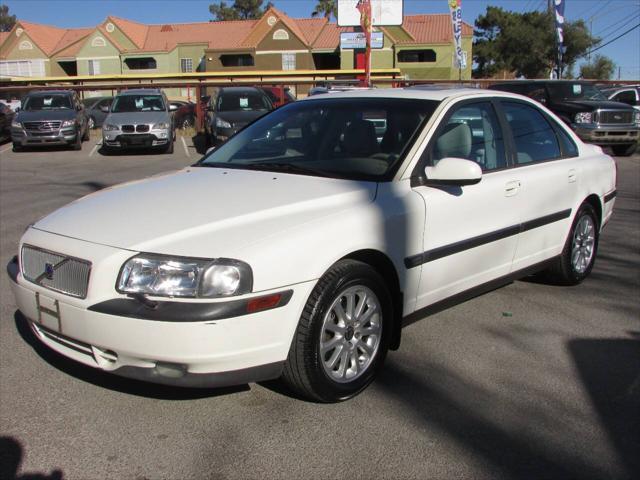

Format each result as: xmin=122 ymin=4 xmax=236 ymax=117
xmin=2 ymin=0 xmax=640 ymax=79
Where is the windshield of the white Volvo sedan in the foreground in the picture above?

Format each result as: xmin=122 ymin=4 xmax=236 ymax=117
xmin=198 ymin=98 xmax=437 ymax=181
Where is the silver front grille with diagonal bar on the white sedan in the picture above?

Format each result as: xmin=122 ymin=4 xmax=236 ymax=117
xmin=20 ymin=245 xmax=91 ymax=298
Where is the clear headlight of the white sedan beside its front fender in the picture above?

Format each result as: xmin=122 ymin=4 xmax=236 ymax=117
xmin=117 ymin=254 xmax=253 ymax=298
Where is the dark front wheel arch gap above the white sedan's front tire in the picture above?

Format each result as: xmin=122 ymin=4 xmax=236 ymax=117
xmin=340 ymin=249 xmax=403 ymax=350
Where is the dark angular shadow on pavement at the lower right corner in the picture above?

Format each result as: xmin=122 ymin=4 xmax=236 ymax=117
xmin=567 ymin=332 xmax=640 ymax=478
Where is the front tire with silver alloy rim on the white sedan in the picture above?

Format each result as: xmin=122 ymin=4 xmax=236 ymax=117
xmin=282 ymin=260 xmax=393 ymax=403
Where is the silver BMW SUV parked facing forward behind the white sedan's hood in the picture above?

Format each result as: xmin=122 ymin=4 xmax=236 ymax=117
xmin=102 ymin=88 xmax=176 ymax=153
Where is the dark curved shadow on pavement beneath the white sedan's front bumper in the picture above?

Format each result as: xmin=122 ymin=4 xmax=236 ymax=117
xmin=14 ymin=311 xmax=250 ymax=402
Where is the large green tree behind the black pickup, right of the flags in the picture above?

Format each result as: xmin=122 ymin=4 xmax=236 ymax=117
xmin=473 ymin=7 xmax=600 ymax=78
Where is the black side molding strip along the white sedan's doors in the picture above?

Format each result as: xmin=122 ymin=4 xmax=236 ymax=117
xmin=404 ymin=208 xmax=571 ymax=268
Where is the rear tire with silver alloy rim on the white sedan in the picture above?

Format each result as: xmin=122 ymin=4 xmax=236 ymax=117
xmin=546 ymin=203 xmax=600 ymax=285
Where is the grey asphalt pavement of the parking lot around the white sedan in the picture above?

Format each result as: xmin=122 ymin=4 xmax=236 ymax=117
xmin=0 ymin=138 xmax=640 ymax=480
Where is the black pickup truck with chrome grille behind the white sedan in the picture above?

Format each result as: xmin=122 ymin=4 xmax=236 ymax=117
xmin=489 ymin=80 xmax=640 ymax=156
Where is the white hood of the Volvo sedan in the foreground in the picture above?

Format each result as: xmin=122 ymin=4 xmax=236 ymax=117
xmin=34 ymin=167 xmax=376 ymax=256
